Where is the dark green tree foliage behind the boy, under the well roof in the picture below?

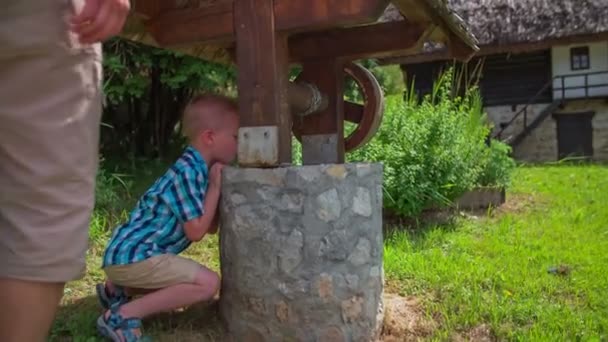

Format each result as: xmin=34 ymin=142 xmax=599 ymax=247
xmin=101 ymin=38 xmax=236 ymax=157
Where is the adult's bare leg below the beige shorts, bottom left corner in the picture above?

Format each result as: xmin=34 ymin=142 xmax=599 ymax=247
xmin=0 ymin=278 xmax=64 ymax=342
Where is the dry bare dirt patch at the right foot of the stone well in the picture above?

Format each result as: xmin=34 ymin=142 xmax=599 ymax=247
xmin=380 ymin=293 xmax=436 ymax=342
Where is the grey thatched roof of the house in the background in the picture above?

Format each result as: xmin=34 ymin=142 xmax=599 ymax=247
xmin=378 ymin=0 xmax=608 ymax=63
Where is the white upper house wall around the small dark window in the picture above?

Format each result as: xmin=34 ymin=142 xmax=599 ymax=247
xmin=551 ymin=41 xmax=608 ymax=99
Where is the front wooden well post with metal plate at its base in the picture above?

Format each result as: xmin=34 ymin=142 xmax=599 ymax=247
xmin=234 ymin=0 xmax=291 ymax=167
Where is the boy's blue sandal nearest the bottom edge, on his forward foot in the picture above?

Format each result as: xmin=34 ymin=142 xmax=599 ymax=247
xmin=97 ymin=305 xmax=151 ymax=342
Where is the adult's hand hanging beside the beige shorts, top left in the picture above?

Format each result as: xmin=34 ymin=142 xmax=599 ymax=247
xmin=71 ymin=0 xmax=131 ymax=44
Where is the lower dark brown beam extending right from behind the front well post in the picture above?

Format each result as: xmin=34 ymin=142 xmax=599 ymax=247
xmin=289 ymin=21 xmax=425 ymax=61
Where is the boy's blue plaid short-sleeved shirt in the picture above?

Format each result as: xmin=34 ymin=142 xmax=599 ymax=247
xmin=102 ymin=146 xmax=208 ymax=267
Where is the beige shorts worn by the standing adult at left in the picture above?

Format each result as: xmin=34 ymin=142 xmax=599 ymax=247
xmin=0 ymin=0 xmax=102 ymax=282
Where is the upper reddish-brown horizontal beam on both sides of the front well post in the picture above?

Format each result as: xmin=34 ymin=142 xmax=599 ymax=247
xmin=150 ymin=0 xmax=389 ymax=46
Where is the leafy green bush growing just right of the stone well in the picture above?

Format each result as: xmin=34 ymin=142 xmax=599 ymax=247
xmin=347 ymin=70 xmax=510 ymax=216
